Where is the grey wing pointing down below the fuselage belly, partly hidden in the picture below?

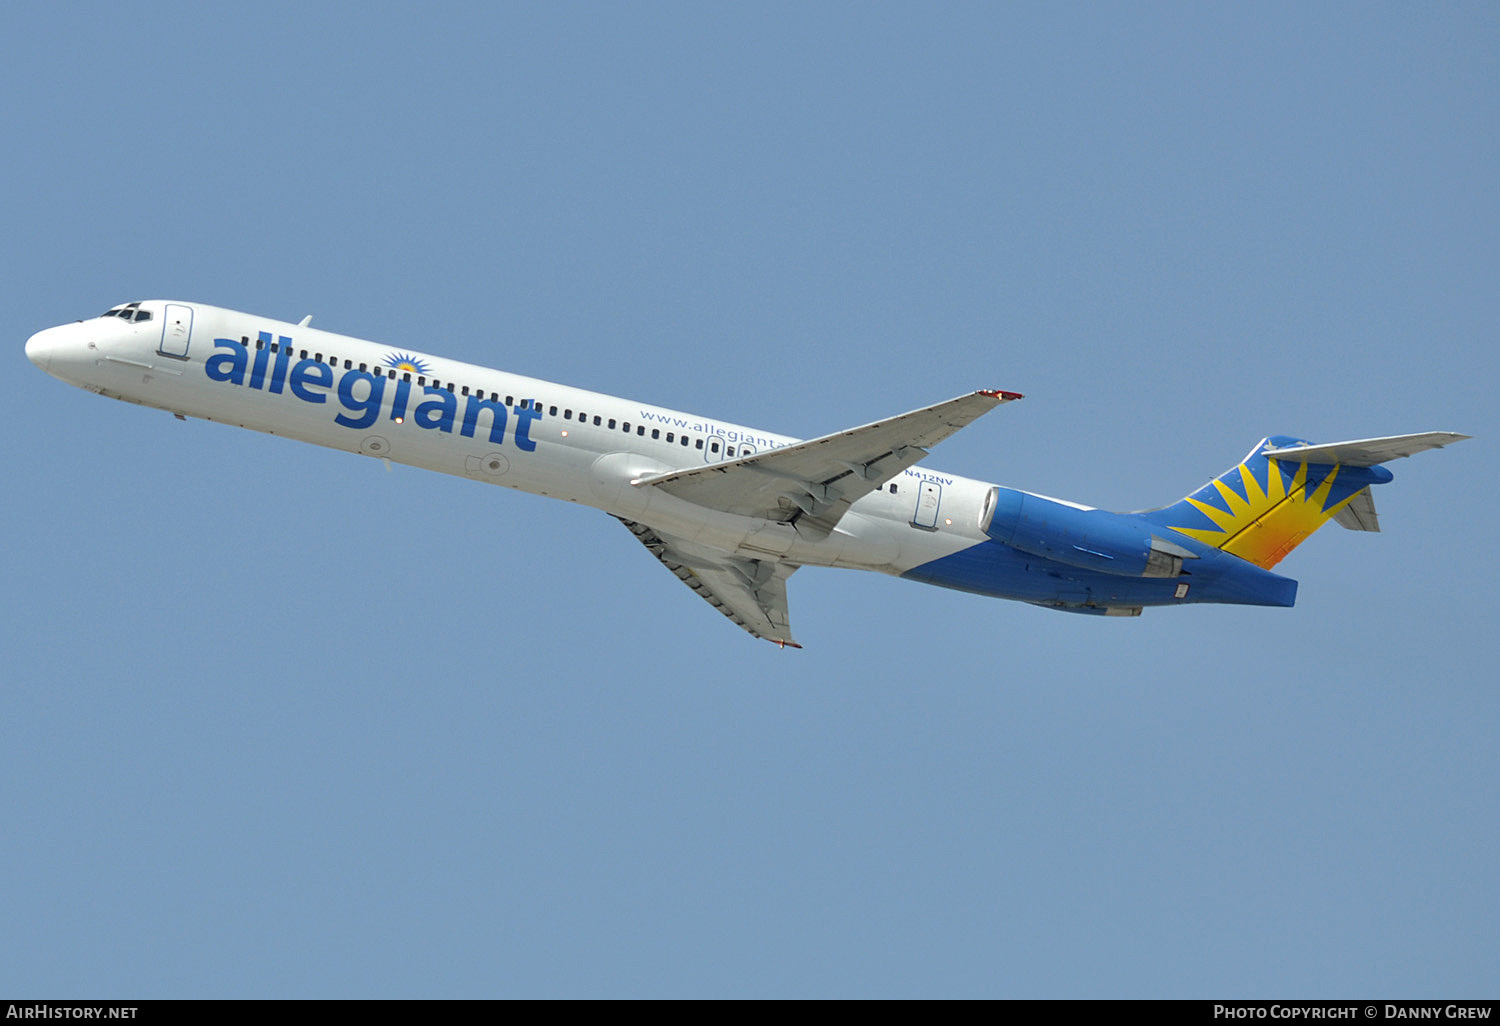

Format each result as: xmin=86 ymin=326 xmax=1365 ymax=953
xmin=617 ymin=518 xmax=801 ymax=648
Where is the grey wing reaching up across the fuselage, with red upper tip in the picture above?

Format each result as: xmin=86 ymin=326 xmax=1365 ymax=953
xmin=636 ymin=390 xmax=1022 ymax=539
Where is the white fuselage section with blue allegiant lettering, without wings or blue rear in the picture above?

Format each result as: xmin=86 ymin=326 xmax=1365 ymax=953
xmin=27 ymin=302 xmax=992 ymax=575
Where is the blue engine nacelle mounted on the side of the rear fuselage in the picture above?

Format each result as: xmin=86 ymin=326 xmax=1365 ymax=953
xmin=980 ymin=488 xmax=1197 ymax=578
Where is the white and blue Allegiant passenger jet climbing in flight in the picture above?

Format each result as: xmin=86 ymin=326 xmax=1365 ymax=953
xmin=26 ymin=300 xmax=1469 ymax=648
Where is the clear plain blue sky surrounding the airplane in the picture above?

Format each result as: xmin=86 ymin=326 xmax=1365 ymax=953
xmin=0 ymin=3 xmax=1500 ymax=998
